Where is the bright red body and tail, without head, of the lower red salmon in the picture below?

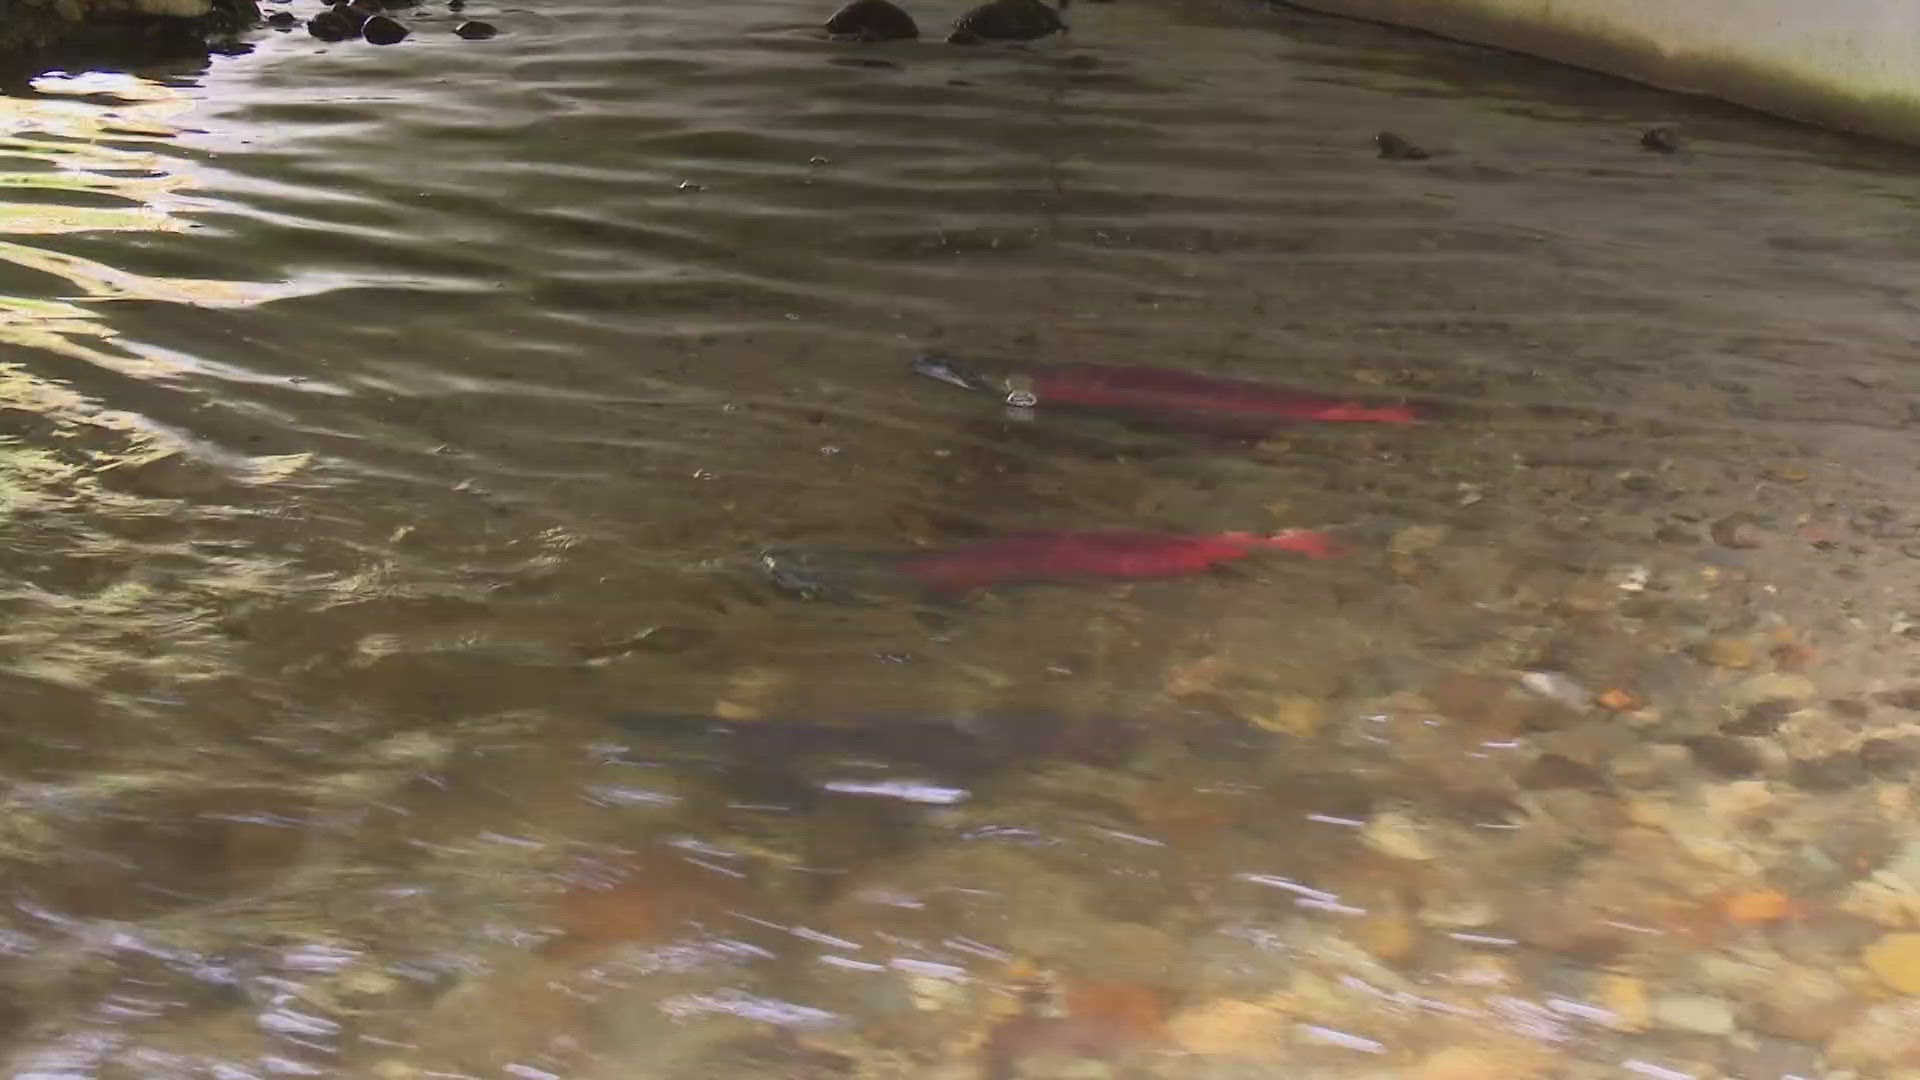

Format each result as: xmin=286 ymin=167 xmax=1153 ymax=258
xmin=899 ymin=528 xmax=1338 ymax=592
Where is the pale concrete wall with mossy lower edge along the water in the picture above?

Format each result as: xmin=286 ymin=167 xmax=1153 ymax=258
xmin=1292 ymin=0 xmax=1920 ymax=142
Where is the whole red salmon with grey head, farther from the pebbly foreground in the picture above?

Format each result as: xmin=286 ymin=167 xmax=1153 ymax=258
xmin=912 ymin=354 xmax=1419 ymax=425
